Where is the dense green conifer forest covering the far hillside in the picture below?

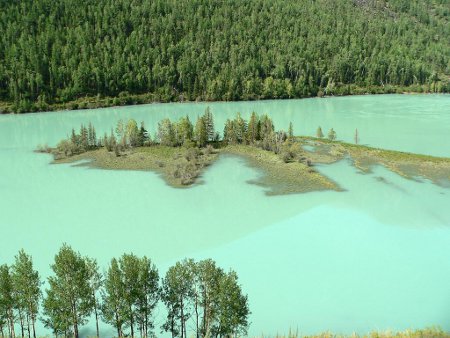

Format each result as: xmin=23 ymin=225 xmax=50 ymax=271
xmin=0 ymin=0 xmax=450 ymax=112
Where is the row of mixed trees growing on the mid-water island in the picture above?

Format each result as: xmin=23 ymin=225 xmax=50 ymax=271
xmin=51 ymin=107 xmax=348 ymax=168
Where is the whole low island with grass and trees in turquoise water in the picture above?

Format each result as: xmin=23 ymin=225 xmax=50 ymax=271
xmin=38 ymin=108 xmax=450 ymax=195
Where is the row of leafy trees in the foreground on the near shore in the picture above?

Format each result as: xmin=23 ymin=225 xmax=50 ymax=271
xmin=0 ymin=244 xmax=250 ymax=338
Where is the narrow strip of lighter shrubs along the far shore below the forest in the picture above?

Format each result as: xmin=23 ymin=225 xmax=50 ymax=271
xmin=0 ymin=84 xmax=448 ymax=114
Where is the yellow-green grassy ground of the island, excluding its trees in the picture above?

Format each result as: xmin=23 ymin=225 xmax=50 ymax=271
xmin=46 ymin=137 xmax=450 ymax=195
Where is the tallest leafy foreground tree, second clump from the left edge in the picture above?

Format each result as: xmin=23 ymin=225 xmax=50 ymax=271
xmin=43 ymin=244 xmax=93 ymax=338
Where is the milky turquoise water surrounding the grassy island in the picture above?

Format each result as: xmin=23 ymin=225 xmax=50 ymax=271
xmin=0 ymin=95 xmax=450 ymax=336
